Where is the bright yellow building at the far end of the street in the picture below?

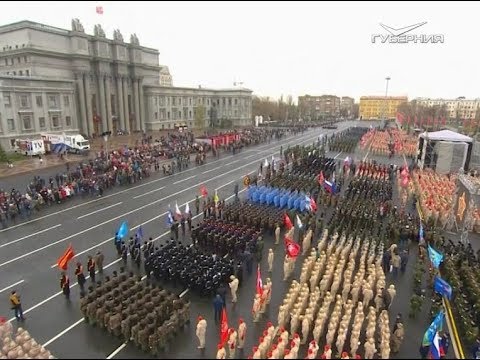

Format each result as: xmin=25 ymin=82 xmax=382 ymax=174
xmin=359 ymin=96 xmax=408 ymax=120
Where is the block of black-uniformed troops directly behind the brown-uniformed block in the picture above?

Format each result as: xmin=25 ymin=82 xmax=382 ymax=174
xmin=145 ymin=241 xmax=234 ymax=295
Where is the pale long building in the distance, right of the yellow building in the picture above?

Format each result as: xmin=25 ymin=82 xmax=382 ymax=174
xmin=415 ymin=97 xmax=480 ymax=119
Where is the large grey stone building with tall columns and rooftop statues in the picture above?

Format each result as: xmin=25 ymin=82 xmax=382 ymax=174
xmin=0 ymin=19 xmax=252 ymax=149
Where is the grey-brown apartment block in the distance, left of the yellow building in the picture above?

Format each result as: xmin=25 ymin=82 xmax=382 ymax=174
xmin=298 ymin=95 xmax=341 ymax=120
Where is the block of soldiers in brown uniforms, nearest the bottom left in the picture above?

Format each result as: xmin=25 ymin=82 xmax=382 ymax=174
xmin=80 ymin=272 xmax=190 ymax=355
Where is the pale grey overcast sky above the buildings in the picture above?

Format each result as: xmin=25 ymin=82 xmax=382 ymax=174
xmin=0 ymin=1 xmax=480 ymax=100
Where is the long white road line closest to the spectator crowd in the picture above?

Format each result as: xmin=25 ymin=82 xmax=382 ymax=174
xmin=0 ymin=131 xmax=320 ymax=233
